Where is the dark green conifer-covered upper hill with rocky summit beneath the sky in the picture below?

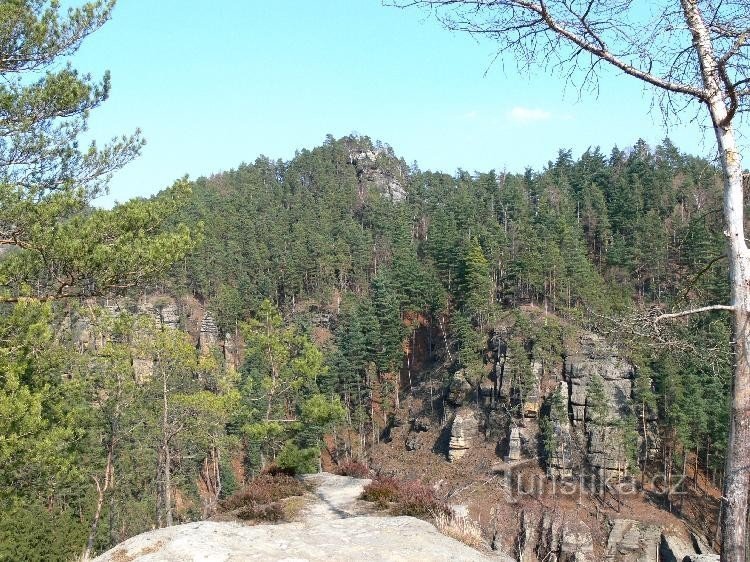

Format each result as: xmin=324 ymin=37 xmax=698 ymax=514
xmin=172 ymin=132 xmax=730 ymax=486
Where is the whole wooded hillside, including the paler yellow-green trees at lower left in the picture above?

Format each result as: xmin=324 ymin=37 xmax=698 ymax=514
xmin=0 ymin=132 xmax=731 ymax=560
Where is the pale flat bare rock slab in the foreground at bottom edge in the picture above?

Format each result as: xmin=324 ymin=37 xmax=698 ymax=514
xmin=96 ymin=516 xmax=498 ymax=562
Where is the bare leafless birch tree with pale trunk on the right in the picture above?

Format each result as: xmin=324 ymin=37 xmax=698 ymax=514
xmin=394 ymin=0 xmax=750 ymax=562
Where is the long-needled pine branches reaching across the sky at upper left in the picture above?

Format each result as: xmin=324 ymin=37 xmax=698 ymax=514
xmin=0 ymin=0 xmax=197 ymax=301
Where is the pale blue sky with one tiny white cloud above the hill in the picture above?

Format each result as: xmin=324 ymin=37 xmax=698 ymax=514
xmin=73 ymin=0 xmax=736 ymax=205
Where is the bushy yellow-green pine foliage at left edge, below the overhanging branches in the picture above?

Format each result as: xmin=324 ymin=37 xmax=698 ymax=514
xmin=0 ymin=301 xmax=81 ymax=505
